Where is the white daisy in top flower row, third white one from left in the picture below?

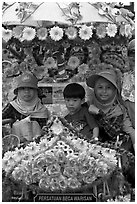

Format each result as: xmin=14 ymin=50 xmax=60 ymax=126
xmin=49 ymin=26 xmax=63 ymax=41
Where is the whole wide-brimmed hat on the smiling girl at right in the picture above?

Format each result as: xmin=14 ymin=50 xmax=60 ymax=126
xmin=86 ymin=70 xmax=119 ymax=90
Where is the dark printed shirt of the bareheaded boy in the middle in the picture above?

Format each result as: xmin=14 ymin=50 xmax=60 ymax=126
xmin=65 ymin=107 xmax=97 ymax=139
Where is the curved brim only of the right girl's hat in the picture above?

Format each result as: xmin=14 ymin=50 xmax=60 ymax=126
xmin=86 ymin=74 xmax=119 ymax=90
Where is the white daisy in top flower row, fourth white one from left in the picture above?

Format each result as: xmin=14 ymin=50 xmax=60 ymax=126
xmin=79 ymin=25 xmax=93 ymax=40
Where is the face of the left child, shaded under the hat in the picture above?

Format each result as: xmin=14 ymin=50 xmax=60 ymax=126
xmin=18 ymin=87 xmax=37 ymax=102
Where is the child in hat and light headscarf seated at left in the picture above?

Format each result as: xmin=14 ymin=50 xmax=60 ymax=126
xmin=2 ymin=72 xmax=50 ymax=142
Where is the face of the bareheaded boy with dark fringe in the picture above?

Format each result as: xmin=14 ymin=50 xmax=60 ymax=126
xmin=65 ymin=98 xmax=83 ymax=114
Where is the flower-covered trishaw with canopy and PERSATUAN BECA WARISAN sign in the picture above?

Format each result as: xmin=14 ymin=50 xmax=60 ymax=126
xmin=2 ymin=2 xmax=135 ymax=202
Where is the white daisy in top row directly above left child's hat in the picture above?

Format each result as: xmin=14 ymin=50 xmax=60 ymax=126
xmin=21 ymin=27 xmax=36 ymax=41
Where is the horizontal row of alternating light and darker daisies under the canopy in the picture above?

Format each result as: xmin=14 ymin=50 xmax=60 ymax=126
xmin=2 ymin=23 xmax=134 ymax=42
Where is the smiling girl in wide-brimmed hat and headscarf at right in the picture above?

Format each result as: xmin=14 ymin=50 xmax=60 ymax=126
xmin=86 ymin=67 xmax=135 ymax=186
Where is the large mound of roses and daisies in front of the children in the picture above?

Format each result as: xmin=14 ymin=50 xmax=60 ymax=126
xmin=2 ymin=116 xmax=134 ymax=199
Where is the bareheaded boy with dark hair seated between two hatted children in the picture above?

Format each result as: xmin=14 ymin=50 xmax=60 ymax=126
xmin=63 ymin=83 xmax=99 ymax=140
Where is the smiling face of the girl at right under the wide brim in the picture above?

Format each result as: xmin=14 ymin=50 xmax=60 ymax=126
xmin=94 ymin=77 xmax=116 ymax=103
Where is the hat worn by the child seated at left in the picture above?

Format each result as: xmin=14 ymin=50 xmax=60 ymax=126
xmin=14 ymin=72 xmax=38 ymax=94
